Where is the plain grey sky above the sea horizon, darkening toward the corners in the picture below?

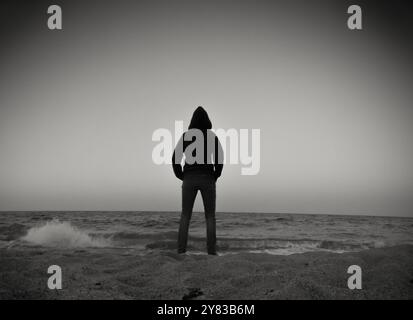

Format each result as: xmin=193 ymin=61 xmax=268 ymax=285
xmin=0 ymin=0 xmax=413 ymax=216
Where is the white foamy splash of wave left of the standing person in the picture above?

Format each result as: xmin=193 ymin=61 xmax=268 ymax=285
xmin=22 ymin=219 xmax=109 ymax=248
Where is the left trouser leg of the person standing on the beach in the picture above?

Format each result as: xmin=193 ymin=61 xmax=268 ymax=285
xmin=178 ymin=179 xmax=198 ymax=253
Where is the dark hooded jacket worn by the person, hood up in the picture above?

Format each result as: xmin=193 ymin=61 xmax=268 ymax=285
xmin=172 ymin=107 xmax=224 ymax=180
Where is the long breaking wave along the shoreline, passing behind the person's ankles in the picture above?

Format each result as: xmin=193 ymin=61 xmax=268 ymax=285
xmin=16 ymin=219 xmax=394 ymax=254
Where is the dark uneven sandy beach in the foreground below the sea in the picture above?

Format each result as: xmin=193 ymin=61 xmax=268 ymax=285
xmin=0 ymin=245 xmax=413 ymax=299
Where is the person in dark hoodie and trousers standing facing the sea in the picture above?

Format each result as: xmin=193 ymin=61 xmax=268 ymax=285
xmin=172 ymin=107 xmax=223 ymax=254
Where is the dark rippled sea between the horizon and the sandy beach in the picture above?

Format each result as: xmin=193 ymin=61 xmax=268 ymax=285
xmin=0 ymin=211 xmax=413 ymax=255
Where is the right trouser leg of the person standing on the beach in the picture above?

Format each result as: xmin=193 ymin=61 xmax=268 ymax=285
xmin=200 ymin=177 xmax=217 ymax=254
